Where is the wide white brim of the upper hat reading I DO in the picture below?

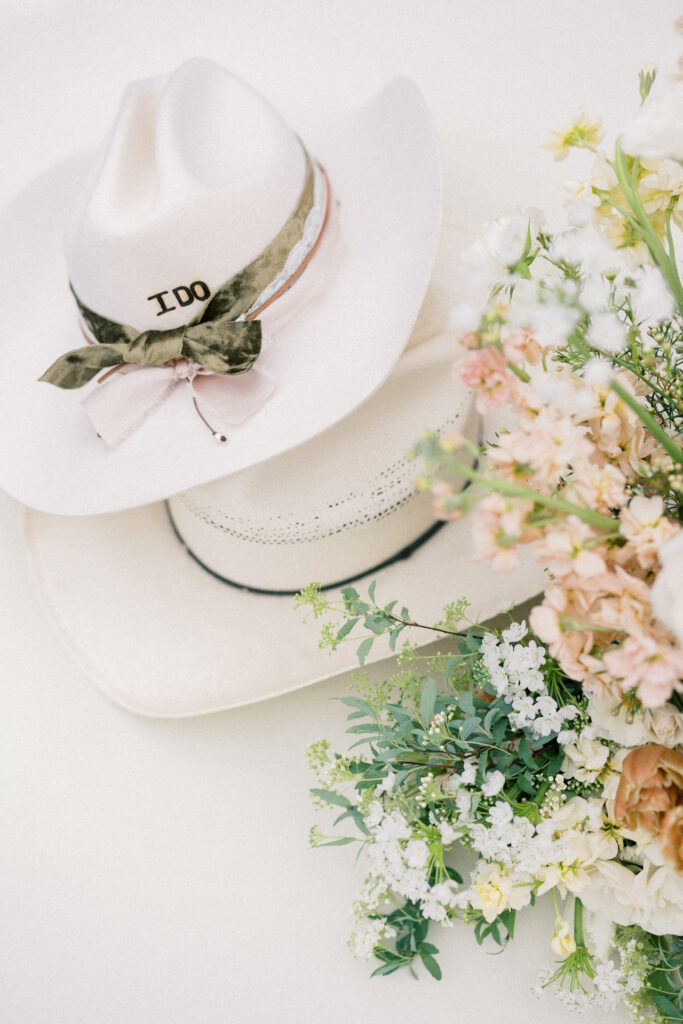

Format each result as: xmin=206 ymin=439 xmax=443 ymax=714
xmin=0 ymin=79 xmax=441 ymax=516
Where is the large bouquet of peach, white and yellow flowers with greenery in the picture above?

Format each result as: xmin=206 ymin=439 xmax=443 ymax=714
xmin=299 ymin=59 xmax=683 ymax=1022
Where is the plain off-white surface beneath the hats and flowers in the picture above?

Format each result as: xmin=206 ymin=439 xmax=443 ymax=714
xmin=0 ymin=0 xmax=681 ymax=1024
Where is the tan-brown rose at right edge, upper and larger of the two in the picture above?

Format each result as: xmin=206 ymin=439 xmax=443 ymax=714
xmin=614 ymin=743 xmax=683 ymax=836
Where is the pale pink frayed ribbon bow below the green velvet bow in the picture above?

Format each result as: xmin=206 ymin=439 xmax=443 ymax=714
xmin=83 ymin=360 xmax=274 ymax=447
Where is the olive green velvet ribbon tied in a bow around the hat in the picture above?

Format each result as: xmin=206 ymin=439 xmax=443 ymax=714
xmin=40 ymin=148 xmax=314 ymax=388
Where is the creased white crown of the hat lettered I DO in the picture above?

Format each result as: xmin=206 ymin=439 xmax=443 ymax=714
xmin=66 ymin=59 xmax=305 ymax=331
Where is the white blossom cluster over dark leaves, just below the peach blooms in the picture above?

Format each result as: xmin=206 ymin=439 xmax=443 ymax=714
xmin=481 ymin=622 xmax=580 ymax=742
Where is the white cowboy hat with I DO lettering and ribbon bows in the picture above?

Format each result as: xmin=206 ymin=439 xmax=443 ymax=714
xmin=0 ymin=59 xmax=441 ymax=515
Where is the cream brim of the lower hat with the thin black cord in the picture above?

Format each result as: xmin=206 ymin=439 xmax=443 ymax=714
xmin=26 ymin=503 xmax=544 ymax=718
